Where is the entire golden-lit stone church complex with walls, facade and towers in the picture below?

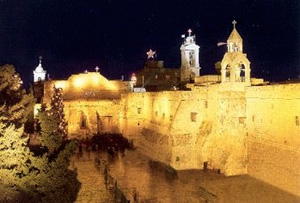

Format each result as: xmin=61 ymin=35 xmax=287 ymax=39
xmin=34 ymin=21 xmax=300 ymax=196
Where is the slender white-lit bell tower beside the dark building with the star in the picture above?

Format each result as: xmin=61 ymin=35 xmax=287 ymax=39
xmin=180 ymin=29 xmax=200 ymax=82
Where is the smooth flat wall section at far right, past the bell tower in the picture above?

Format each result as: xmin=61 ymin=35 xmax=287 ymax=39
xmin=246 ymin=84 xmax=300 ymax=195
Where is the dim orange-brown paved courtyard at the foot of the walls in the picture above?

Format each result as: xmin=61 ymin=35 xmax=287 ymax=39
xmin=73 ymin=150 xmax=300 ymax=203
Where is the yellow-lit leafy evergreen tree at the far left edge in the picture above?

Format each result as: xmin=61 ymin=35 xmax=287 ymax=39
xmin=0 ymin=65 xmax=32 ymax=200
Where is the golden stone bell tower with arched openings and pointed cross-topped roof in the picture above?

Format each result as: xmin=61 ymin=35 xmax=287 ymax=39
xmin=221 ymin=20 xmax=251 ymax=85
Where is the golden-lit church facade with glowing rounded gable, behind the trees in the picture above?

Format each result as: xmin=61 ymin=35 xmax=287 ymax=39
xmin=43 ymin=72 xmax=129 ymax=139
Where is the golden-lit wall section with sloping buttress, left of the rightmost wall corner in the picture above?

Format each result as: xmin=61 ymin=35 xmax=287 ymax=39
xmin=123 ymin=85 xmax=247 ymax=175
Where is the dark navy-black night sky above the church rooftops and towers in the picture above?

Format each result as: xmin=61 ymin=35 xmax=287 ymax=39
xmin=0 ymin=0 xmax=300 ymax=86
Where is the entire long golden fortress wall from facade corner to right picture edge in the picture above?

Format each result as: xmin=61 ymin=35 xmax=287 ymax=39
xmin=120 ymin=83 xmax=300 ymax=195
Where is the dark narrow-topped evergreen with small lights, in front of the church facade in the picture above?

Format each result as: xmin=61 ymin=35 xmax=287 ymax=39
xmin=31 ymin=86 xmax=80 ymax=202
